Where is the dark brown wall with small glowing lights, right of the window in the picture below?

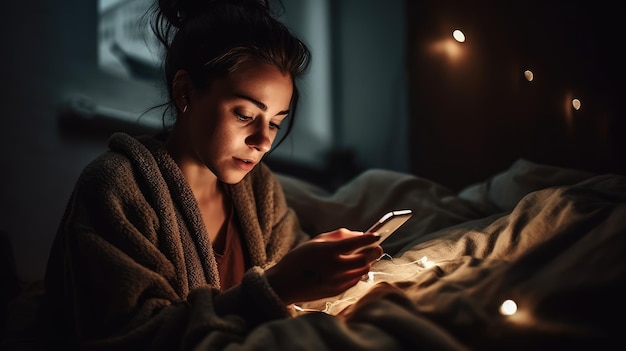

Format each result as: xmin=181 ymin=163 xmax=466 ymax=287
xmin=406 ymin=0 xmax=626 ymax=189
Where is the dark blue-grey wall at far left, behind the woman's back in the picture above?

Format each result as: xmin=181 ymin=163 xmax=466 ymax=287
xmin=0 ymin=0 xmax=161 ymax=280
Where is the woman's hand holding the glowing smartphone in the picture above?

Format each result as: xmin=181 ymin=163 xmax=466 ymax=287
xmin=266 ymin=228 xmax=383 ymax=304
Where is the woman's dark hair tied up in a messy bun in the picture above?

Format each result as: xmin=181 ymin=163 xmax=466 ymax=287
xmin=150 ymin=0 xmax=311 ymax=145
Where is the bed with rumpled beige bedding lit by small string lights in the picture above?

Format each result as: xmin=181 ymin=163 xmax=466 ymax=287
xmin=239 ymin=159 xmax=626 ymax=350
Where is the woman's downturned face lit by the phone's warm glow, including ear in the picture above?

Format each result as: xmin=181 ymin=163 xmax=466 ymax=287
xmin=179 ymin=62 xmax=293 ymax=184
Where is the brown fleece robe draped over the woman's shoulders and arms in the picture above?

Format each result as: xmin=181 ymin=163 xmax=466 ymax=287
xmin=37 ymin=133 xmax=308 ymax=350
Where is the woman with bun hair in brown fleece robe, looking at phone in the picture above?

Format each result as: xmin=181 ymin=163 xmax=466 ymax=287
xmin=42 ymin=0 xmax=382 ymax=350
